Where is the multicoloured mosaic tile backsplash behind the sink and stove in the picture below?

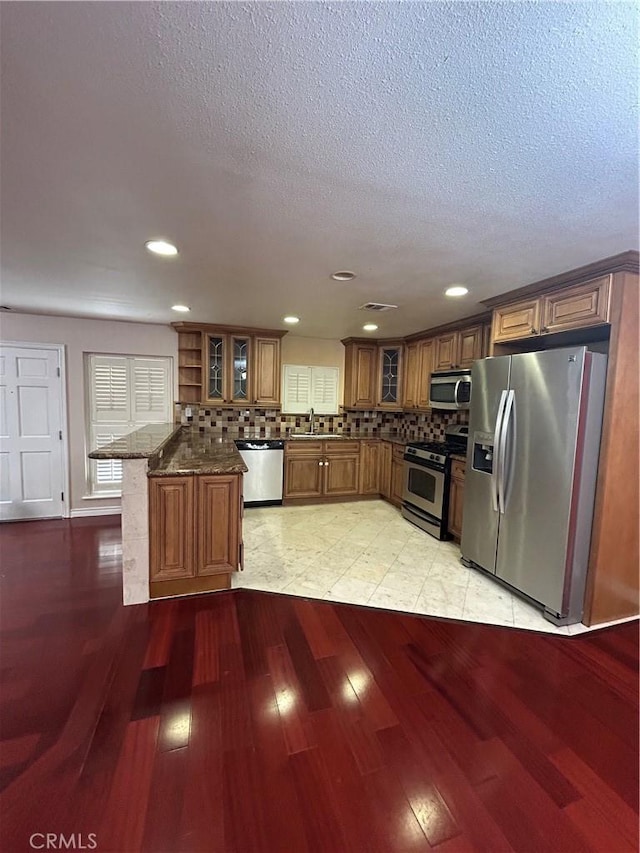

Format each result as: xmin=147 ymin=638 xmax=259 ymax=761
xmin=176 ymin=403 xmax=468 ymax=441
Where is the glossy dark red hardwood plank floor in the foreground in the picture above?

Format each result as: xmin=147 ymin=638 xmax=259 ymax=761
xmin=0 ymin=518 xmax=638 ymax=853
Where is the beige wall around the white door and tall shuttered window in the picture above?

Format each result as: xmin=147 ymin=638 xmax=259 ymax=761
xmin=0 ymin=313 xmax=178 ymax=514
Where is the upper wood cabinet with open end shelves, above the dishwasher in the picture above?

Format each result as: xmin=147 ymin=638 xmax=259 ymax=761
xmin=173 ymin=323 xmax=286 ymax=408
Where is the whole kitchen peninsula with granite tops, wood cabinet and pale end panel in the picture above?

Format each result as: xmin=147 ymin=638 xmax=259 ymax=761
xmin=89 ymin=424 xmax=247 ymax=604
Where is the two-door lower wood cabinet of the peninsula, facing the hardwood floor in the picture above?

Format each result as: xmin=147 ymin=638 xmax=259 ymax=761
xmin=149 ymin=474 xmax=242 ymax=598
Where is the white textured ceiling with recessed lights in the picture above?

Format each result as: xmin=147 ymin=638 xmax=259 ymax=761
xmin=0 ymin=2 xmax=639 ymax=338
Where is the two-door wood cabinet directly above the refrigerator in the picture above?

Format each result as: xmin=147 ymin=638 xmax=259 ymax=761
xmin=492 ymin=275 xmax=611 ymax=344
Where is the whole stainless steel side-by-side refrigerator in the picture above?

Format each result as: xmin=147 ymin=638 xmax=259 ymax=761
xmin=460 ymin=346 xmax=606 ymax=624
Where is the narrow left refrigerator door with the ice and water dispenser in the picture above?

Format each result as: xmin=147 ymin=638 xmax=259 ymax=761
xmin=460 ymin=356 xmax=511 ymax=573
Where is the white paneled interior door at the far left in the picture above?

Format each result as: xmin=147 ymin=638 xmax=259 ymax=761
xmin=0 ymin=345 xmax=64 ymax=521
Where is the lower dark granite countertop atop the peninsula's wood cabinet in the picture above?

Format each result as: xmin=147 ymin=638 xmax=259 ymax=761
xmin=149 ymin=429 xmax=248 ymax=477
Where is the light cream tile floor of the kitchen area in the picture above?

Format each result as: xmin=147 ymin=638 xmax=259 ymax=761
xmin=233 ymin=501 xmax=640 ymax=635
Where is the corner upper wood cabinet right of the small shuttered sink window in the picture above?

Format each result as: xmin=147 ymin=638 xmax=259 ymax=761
xmin=342 ymin=338 xmax=403 ymax=411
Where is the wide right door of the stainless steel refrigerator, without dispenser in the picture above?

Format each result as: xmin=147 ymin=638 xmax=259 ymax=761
xmin=496 ymin=347 xmax=586 ymax=613
